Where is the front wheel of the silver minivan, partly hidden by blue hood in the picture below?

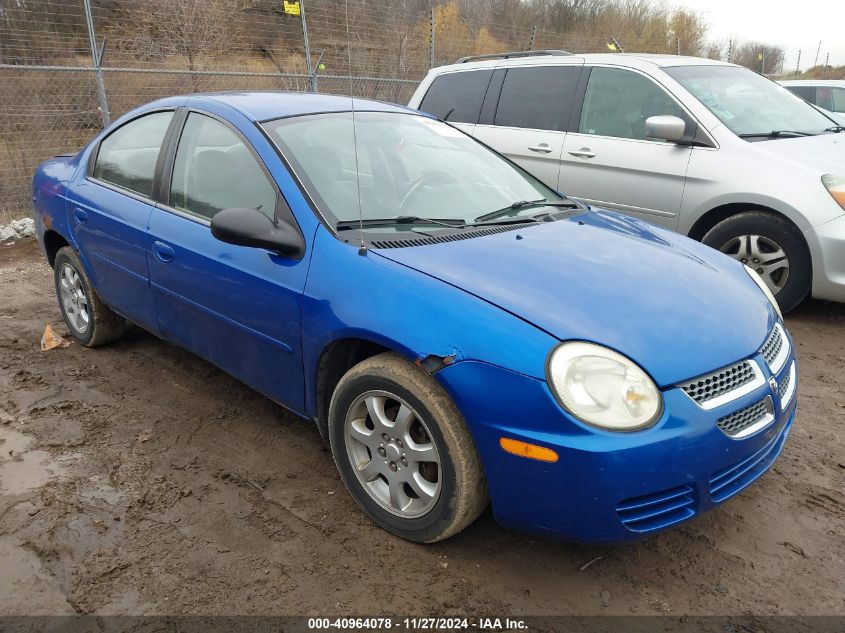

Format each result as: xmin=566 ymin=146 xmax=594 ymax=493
xmin=702 ymin=211 xmax=813 ymax=312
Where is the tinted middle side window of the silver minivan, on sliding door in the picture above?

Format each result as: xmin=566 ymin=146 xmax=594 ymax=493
xmin=494 ymin=66 xmax=581 ymax=130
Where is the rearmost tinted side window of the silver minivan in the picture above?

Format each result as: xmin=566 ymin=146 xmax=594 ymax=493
xmin=420 ymin=70 xmax=493 ymax=123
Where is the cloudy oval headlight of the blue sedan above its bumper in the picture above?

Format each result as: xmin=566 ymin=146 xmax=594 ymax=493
xmin=546 ymin=341 xmax=663 ymax=431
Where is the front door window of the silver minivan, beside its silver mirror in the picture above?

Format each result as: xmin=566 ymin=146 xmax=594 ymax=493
xmin=578 ymin=67 xmax=684 ymax=140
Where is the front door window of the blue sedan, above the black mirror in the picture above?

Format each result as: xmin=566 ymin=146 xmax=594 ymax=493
xmin=170 ymin=112 xmax=276 ymax=220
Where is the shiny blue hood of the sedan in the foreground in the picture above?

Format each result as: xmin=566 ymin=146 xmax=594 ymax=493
xmin=374 ymin=211 xmax=775 ymax=386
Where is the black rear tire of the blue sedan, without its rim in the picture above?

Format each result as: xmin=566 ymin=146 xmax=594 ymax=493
xmin=53 ymin=246 xmax=126 ymax=347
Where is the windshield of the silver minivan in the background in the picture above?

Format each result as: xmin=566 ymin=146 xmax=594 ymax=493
xmin=664 ymin=65 xmax=833 ymax=135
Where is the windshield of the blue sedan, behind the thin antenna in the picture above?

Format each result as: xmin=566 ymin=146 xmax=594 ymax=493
xmin=264 ymin=112 xmax=562 ymax=230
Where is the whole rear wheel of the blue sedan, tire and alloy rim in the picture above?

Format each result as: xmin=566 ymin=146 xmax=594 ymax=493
xmin=53 ymin=246 xmax=126 ymax=347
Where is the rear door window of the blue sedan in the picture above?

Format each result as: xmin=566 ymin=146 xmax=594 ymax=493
xmin=92 ymin=111 xmax=173 ymax=198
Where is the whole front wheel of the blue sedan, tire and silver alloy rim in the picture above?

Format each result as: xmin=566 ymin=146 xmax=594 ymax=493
xmin=328 ymin=352 xmax=488 ymax=543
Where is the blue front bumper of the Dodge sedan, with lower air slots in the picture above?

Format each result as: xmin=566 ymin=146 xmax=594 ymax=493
xmin=437 ymin=341 xmax=797 ymax=542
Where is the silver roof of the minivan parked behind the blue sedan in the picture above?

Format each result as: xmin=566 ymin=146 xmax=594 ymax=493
xmin=431 ymin=53 xmax=736 ymax=73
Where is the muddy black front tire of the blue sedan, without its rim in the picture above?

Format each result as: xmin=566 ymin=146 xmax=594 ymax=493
xmin=329 ymin=353 xmax=488 ymax=543
